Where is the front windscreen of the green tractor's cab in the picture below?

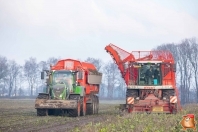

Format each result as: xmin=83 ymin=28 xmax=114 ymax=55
xmin=53 ymin=72 xmax=73 ymax=87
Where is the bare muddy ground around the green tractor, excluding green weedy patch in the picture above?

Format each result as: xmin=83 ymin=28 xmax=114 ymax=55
xmin=0 ymin=99 xmax=120 ymax=132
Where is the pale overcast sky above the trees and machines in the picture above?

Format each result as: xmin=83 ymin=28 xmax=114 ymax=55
xmin=0 ymin=0 xmax=198 ymax=64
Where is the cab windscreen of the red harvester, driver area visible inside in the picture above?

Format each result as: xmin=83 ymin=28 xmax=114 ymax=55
xmin=139 ymin=63 xmax=161 ymax=85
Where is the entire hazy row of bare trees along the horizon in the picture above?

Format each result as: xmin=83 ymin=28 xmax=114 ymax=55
xmin=0 ymin=38 xmax=198 ymax=104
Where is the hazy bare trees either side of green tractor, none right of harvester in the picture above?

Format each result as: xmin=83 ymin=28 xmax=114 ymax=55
xmin=0 ymin=56 xmax=125 ymax=98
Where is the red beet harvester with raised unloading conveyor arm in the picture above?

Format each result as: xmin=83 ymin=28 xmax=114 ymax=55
xmin=105 ymin=44 xmax=181 ymax=113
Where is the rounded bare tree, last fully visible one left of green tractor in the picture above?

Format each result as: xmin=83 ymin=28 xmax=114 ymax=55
xmin=24 ymin=57 xmax=38 ymax=96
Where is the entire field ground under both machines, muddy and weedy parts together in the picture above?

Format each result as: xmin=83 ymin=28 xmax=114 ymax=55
xmin=0 ymin=99 xmax=198 ymax=132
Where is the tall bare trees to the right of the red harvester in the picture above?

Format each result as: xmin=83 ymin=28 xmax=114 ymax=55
xmin=154 ymin=38 xmax=198 ymax=104
